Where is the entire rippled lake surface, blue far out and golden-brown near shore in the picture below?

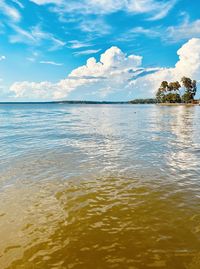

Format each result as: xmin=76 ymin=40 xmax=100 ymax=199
xmin=0 ymin=104 xmax=200 ymax=269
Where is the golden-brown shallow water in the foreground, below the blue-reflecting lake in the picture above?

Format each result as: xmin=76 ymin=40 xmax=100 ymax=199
xmin=0 ymin=178 xmax=200 ymax=269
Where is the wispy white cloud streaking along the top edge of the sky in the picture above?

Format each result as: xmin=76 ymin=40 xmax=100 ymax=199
xmin=31 ymin=0 xmax=176 ymax=20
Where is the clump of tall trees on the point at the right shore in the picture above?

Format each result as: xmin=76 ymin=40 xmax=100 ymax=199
xmin=156 ymin=77 xmax=197 ymax=103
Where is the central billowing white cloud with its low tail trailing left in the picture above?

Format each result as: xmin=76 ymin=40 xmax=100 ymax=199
xmin=10 ymin=47 xmax=142 ymax=99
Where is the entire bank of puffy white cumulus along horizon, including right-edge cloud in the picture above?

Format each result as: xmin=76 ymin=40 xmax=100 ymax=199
xmin=10 ymin=38 xmax=200 ymax=99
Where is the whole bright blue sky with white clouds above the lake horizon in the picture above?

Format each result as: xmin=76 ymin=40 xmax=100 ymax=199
xmin=0 ymin=0 xmax=200 ymax=101
